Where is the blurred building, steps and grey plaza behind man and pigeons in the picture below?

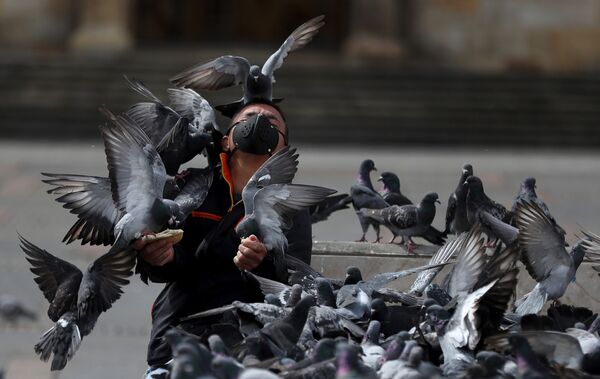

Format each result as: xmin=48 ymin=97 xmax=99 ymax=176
xmin=0 ymin=0 xmax=600 ymax=379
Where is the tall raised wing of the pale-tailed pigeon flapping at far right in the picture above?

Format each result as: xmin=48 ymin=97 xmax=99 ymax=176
xmin=515 ymin=202 xmax=571 ymax=282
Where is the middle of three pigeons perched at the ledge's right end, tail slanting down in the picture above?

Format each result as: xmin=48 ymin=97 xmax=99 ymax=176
xmin=465 ymin=176 xmax=518 ymax=245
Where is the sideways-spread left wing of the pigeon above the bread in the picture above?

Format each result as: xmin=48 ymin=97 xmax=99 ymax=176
xmin=42 ymin=173 xmax=121 ymax=245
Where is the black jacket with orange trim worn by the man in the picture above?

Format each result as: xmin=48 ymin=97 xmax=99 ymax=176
xmin=144 ymin=157 xmax=312 ymax=366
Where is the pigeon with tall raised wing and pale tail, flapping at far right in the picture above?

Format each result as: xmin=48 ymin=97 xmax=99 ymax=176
xmin=515 ymin=200 xmax=586 ymax=315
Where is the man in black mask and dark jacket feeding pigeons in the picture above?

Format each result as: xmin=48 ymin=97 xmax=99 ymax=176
xmin=134 ymin=101 xmax=312 ymax=378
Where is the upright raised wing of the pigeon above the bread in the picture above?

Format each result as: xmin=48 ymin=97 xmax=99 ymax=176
xmin=100 ymin=111 xmax=166 ymax=213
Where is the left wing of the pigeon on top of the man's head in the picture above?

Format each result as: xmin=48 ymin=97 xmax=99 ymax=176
xmin=171 ymin=55 xmax=250 ymax=90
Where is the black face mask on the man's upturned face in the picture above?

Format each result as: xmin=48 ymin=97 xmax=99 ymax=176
xmin=231 ymin=113 xmax=285 ymax=156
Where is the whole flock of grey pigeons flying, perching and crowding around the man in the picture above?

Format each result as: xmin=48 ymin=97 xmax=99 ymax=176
xmin=8 ymin=11 xmax=600 ymax=379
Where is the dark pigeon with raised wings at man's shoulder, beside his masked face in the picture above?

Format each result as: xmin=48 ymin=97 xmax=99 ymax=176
xmin=125 ymin=77 xmax=216 ymax=176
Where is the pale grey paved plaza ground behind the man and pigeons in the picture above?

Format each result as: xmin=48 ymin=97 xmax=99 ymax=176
xmin=0 ymin=141 xmax=600 ymax=379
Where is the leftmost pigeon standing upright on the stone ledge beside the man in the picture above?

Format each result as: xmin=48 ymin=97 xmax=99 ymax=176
xmin=350 ymin=159 xmax=389 ymax=242
